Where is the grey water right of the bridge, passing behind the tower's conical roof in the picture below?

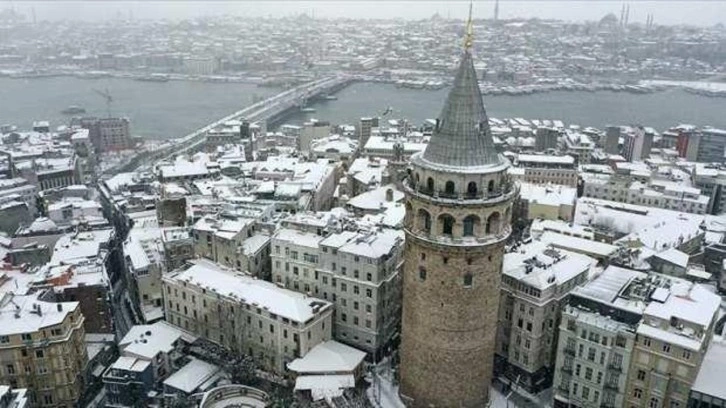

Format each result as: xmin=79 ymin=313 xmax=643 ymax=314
xmin=288 ymin=83 xmax=726 ymax=131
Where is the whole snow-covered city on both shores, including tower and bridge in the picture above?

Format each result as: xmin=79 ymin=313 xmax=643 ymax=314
xmin=0 ymin=2 xmax=726 ymax=408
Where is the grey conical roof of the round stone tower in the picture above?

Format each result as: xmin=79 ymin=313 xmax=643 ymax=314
xmin=423 ymin=47 xmax=501 ymax=168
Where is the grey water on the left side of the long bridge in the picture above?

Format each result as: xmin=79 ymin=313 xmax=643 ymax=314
xmin=0 ymin=77 xmax=280 ymax=139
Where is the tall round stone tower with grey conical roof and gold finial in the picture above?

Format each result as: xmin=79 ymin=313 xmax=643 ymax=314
xmin=400 ymin=6 xmax=518 ymax=408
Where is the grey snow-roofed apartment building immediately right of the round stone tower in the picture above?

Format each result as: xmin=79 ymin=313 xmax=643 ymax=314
xmin=496 ymin=241 xmax=597 ymax=393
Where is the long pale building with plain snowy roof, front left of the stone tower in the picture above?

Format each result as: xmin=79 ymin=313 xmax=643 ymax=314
xmin=163 ymin=259 xmax=333 ymax=374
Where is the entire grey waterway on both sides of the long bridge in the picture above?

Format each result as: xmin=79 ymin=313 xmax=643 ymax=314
xmin=0 ymin=77 xmax=726 ymax=139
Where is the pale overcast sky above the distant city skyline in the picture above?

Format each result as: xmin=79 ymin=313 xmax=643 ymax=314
xmin=5 ymin=0 xmax=726 ymax=25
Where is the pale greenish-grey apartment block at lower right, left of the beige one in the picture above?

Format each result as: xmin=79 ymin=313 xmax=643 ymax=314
xmin=553 ymin=266 xmax=647 ymax=408
